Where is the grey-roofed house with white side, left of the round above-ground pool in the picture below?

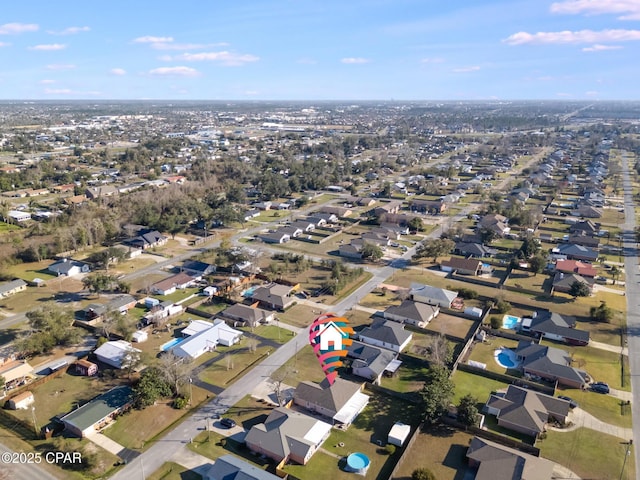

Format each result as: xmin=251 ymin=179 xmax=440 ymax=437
xmin=245 ymin=407 xmax=331 ymax=466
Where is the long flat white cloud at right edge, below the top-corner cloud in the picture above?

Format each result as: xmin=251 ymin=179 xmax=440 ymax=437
xmin=503 ymin=29 xmax=640 ymax=45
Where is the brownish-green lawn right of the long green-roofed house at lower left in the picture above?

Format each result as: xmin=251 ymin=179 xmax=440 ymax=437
xmin=103 ymin=386 xmax=208 ymax=449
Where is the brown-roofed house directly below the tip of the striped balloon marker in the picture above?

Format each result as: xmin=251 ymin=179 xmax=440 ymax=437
xmin=293 ymin=377 xmax=369 ymax=425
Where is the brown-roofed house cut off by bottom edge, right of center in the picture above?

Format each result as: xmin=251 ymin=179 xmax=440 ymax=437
xmin=467 ymin=437 xmax=556 ymax=480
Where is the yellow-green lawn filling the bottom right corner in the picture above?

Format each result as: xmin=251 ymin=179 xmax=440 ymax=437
xmin=536 ymin=428 xmax=635 ymax=479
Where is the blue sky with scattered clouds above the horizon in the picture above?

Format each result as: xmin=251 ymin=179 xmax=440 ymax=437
xmin=0 ymin=0 xmax=640 ymax=100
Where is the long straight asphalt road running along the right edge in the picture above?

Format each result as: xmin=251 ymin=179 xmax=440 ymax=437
xmin=621 ymin=157 xmax=640 ymax=471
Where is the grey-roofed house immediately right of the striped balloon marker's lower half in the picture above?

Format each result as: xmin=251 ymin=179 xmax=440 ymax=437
xmin=347 ymin=340 xmax=402 ymax=385
